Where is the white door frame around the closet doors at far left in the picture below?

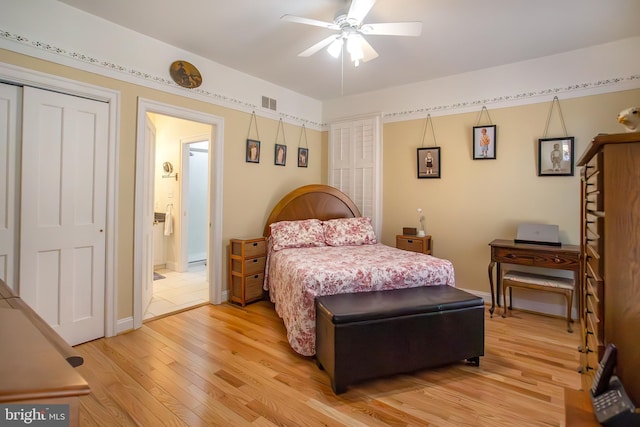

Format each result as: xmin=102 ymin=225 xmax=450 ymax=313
xmin=0 ymin=63 xmax=120 ymax=337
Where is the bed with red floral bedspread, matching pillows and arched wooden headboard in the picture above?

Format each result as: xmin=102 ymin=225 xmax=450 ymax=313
xmin=264 ymin=184 xmax=455 ymax=356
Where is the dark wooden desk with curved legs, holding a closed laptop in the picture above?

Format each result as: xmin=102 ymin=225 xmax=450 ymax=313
xmin=488 ymin=239 xmax=582 ymax=317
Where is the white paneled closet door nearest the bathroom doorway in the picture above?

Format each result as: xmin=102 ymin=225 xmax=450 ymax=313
xmin=19 ymin=87 xmax=109 ymax=345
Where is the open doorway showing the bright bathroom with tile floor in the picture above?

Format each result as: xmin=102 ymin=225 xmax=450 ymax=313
xmin=144 ymin=130 xmax=211 ymax=320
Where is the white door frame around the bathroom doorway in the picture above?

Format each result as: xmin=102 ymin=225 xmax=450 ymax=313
xmin=133 ymin=97 xmax=224 ymax=329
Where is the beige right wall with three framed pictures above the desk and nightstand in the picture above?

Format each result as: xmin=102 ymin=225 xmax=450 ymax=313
xmin=381 ymin=90 xmax=640 ymax=292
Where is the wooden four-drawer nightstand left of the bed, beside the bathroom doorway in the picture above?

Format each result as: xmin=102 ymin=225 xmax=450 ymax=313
xmin=229 ymin=237 xmax=267 ymax=307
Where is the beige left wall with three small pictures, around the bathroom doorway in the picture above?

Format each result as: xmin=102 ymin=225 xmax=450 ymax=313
xmin=0 ymin=49 xmax=326 ymax=319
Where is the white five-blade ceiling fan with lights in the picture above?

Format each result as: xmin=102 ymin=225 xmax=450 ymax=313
xmin=281 ymin=0 xmax=422 ymax=67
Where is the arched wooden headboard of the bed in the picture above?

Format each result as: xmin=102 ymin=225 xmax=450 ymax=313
xmin=263 ymin=184 xmax=361 ymax=237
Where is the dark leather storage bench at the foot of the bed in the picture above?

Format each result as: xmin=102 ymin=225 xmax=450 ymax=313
xmin=316 ymin=286 xmax=484 ymax=394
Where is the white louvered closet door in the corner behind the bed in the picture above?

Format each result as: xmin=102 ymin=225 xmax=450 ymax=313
xmin=329 ymin=116 xmax=382 ymax=236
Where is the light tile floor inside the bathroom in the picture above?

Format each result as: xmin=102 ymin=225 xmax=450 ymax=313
xmin=144 ymin=263 xmax=209 ymax=320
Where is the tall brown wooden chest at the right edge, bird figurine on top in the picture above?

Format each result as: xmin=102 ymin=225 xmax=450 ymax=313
xmin=577 ymin=132 xmax=640 ymax=405
